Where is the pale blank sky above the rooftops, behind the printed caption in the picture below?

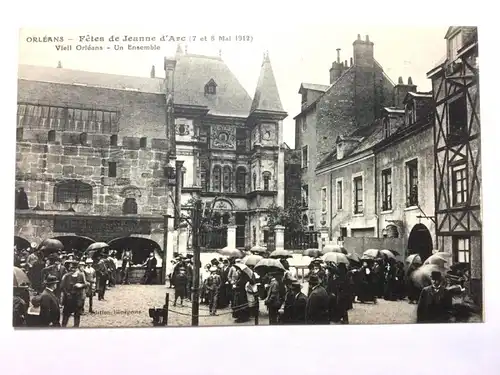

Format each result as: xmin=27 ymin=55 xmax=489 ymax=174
xmin=19 ymin=25 xmax=448 ymax=147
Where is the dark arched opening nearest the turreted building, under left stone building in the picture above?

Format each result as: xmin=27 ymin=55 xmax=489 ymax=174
xmin=108 ymin=237 xmax=163 ymax=267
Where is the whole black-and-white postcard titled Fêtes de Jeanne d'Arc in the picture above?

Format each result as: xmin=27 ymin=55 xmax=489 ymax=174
xmin=12 ymin=25 xmax=483 ymax=328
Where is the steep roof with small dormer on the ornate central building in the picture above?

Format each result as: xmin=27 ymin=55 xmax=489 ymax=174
xmin=174 ymin=54 xmax=252 ymax=117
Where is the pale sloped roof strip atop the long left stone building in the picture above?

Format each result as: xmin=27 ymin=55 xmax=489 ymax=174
xmin=17 ymin=64 xmax=164 ymax=94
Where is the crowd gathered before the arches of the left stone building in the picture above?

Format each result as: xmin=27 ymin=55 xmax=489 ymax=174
xmin=13 ymin=244 xmax=156 ymax=327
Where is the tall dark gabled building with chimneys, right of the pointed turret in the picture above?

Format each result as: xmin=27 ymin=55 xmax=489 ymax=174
xmin=295 ymin=35 xmax=394 ymax=228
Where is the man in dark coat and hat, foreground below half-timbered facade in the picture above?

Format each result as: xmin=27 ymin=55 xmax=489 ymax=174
xmin=417 ymin=271 xmax=452 ymax=323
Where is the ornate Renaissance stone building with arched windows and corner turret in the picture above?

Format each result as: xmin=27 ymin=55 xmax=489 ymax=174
xmin=170 ymin=50 xmax=288 ymax=248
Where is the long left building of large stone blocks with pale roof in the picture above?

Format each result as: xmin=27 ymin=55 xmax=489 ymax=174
xmin=15 ymin=65 xmax=172 ymax=268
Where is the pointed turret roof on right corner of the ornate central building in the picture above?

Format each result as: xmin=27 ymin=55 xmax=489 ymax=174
xmin=250 ymin=52 xmax=284 ymax=112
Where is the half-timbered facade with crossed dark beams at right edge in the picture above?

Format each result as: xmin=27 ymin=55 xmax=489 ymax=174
xmin=427 ymin=27 xmax=482 ymax=306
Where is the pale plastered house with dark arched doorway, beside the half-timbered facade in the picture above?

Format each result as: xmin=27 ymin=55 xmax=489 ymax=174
xmin=316 ymin=74 xmax=435 ymax=258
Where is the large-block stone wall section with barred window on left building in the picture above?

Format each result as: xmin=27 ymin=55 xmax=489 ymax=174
xmin=16 ymin=139 xmax=167 ymax=215
